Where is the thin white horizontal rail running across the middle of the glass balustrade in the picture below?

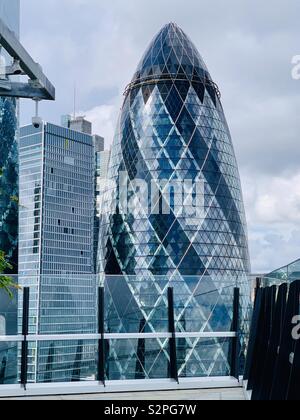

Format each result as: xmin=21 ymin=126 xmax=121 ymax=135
xmin=0 ymin=332 xmax=237 ymax=343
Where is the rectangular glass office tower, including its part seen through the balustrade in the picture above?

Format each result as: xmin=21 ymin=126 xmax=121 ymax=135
xmin=19 ymin=123 xmax=97 ymax=382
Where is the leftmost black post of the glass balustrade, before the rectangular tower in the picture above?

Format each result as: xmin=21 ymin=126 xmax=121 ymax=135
xmin=20 ymin=287 xmax=30 ymax=390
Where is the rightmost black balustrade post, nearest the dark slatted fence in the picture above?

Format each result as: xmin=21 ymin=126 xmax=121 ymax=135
xmin=230 ymin=287 xmax=240 ymax=379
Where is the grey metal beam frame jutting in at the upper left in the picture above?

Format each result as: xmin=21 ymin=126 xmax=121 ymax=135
xmin=0 ymin=19 xmax=55 ymax=101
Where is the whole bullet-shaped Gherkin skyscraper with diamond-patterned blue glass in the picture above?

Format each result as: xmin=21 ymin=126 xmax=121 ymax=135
xmin=99 ymin=23 xmax=250 ymax=378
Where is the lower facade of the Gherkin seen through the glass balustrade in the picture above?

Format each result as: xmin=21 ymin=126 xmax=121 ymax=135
xmin=103 ymin=275 xmax=241 ymax=380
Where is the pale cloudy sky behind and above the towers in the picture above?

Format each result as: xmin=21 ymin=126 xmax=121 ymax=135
xmin=21 ymin=0 xmax=300 ymax=272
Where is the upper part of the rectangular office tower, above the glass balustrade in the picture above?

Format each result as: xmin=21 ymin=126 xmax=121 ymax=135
xmin=19 ymin=123 xmax=94 ymax=276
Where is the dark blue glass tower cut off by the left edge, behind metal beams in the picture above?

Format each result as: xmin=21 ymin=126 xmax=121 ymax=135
xmin=0 ymin=0 xmax=20 ymax=273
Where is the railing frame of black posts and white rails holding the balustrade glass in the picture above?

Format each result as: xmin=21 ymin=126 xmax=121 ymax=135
xmin=0 ymin=287 xmax=240 ymax=397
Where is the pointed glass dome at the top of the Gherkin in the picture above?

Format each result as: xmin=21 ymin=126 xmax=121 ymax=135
xmin=132 ymin=23 xmax=211 ymax=83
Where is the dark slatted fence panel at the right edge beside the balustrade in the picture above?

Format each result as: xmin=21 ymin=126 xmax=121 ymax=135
xmin=244 ymin=281 xmax=300 ymax=401
